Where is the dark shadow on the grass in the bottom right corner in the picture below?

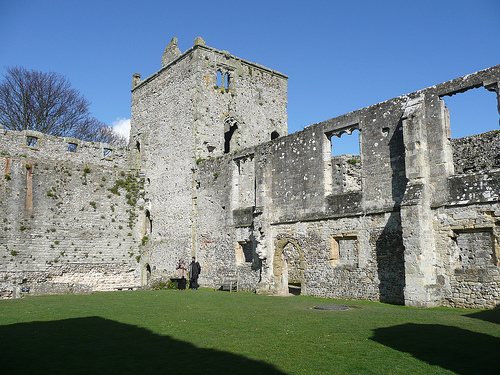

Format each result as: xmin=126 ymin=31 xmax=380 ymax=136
xmin=370 ymin=324 xmax=500 ymax=375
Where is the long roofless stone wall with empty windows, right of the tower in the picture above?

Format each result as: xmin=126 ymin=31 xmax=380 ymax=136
xmin=192 ymin=62 xmax=500 ymax=307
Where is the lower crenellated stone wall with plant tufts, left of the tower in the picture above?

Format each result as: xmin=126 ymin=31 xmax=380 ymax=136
xmin=0 ymin=131 xmax=140 ymax=295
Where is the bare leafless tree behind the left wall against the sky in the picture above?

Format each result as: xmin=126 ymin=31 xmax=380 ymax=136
xmin=0 ymin=67 xmax=126 ymax=147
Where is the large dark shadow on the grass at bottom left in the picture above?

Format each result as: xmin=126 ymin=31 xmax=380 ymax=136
xmin=0 ymin=317 xmax=284 ymax=375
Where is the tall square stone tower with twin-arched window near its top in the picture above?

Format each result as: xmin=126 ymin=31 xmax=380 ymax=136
xmin=130 ymin=37 xmax=288 ymax=273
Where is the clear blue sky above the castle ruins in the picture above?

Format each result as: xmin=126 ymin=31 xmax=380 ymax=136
xmin=0 ymin=0 xmax=500 ymax=153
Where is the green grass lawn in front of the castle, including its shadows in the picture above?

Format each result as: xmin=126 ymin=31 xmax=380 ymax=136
xmin=0 ymin=289 xmax=500 ymax=375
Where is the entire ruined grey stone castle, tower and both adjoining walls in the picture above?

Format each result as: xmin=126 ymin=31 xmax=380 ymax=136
xmin=0 ymin=38 xmax=500 ymax=308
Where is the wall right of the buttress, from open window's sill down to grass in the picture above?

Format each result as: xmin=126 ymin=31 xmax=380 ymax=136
xmin=434 ymin=170 xmax=500 ymax=308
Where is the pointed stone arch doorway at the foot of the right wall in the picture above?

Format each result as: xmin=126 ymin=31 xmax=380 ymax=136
xmin=273 ymin=238 xmax=306 ymax=293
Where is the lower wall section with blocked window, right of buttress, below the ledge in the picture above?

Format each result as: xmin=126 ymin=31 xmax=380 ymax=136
xmin=434 ymin=202 xmax=500 ymax=308
